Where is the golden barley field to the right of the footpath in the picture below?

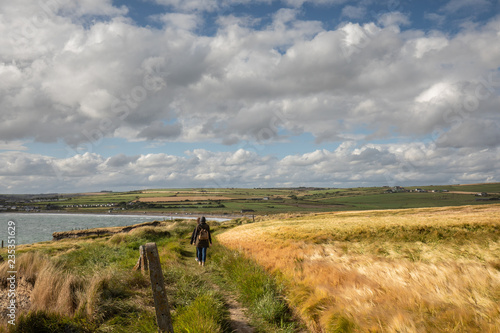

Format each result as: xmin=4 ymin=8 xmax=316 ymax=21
xmin=218 ymin=204 xmax=500 ymax=332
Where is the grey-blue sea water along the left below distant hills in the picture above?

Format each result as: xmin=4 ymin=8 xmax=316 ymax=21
xmin=0 ymin=213 xmax=228 ymax=246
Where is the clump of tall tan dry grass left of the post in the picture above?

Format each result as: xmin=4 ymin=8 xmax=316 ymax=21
xmin=0 ymin=240 xmax=152 ymax=322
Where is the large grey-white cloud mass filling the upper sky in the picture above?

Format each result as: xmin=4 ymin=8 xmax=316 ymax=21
xmin=0 ymin=2 xmax=500 ymax=145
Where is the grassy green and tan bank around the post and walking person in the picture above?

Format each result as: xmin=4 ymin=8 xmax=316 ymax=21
xmin=0 ymin=221 xmax=297 ymax=333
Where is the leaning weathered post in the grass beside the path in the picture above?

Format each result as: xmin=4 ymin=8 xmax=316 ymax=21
xmin=145 ymin=243 xmax=174 ymax=333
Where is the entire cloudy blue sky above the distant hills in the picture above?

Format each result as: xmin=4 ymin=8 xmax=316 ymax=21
xmin=0 ymin=0 xmax=500 ymax=194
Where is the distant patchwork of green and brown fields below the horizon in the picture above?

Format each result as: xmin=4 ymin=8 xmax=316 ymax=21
xmin=10 ymin=183 xmax=500 ymax=215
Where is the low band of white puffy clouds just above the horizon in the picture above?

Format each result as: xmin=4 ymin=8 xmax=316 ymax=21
xmin=0 ymin=142 xmax=500 ymax=192
